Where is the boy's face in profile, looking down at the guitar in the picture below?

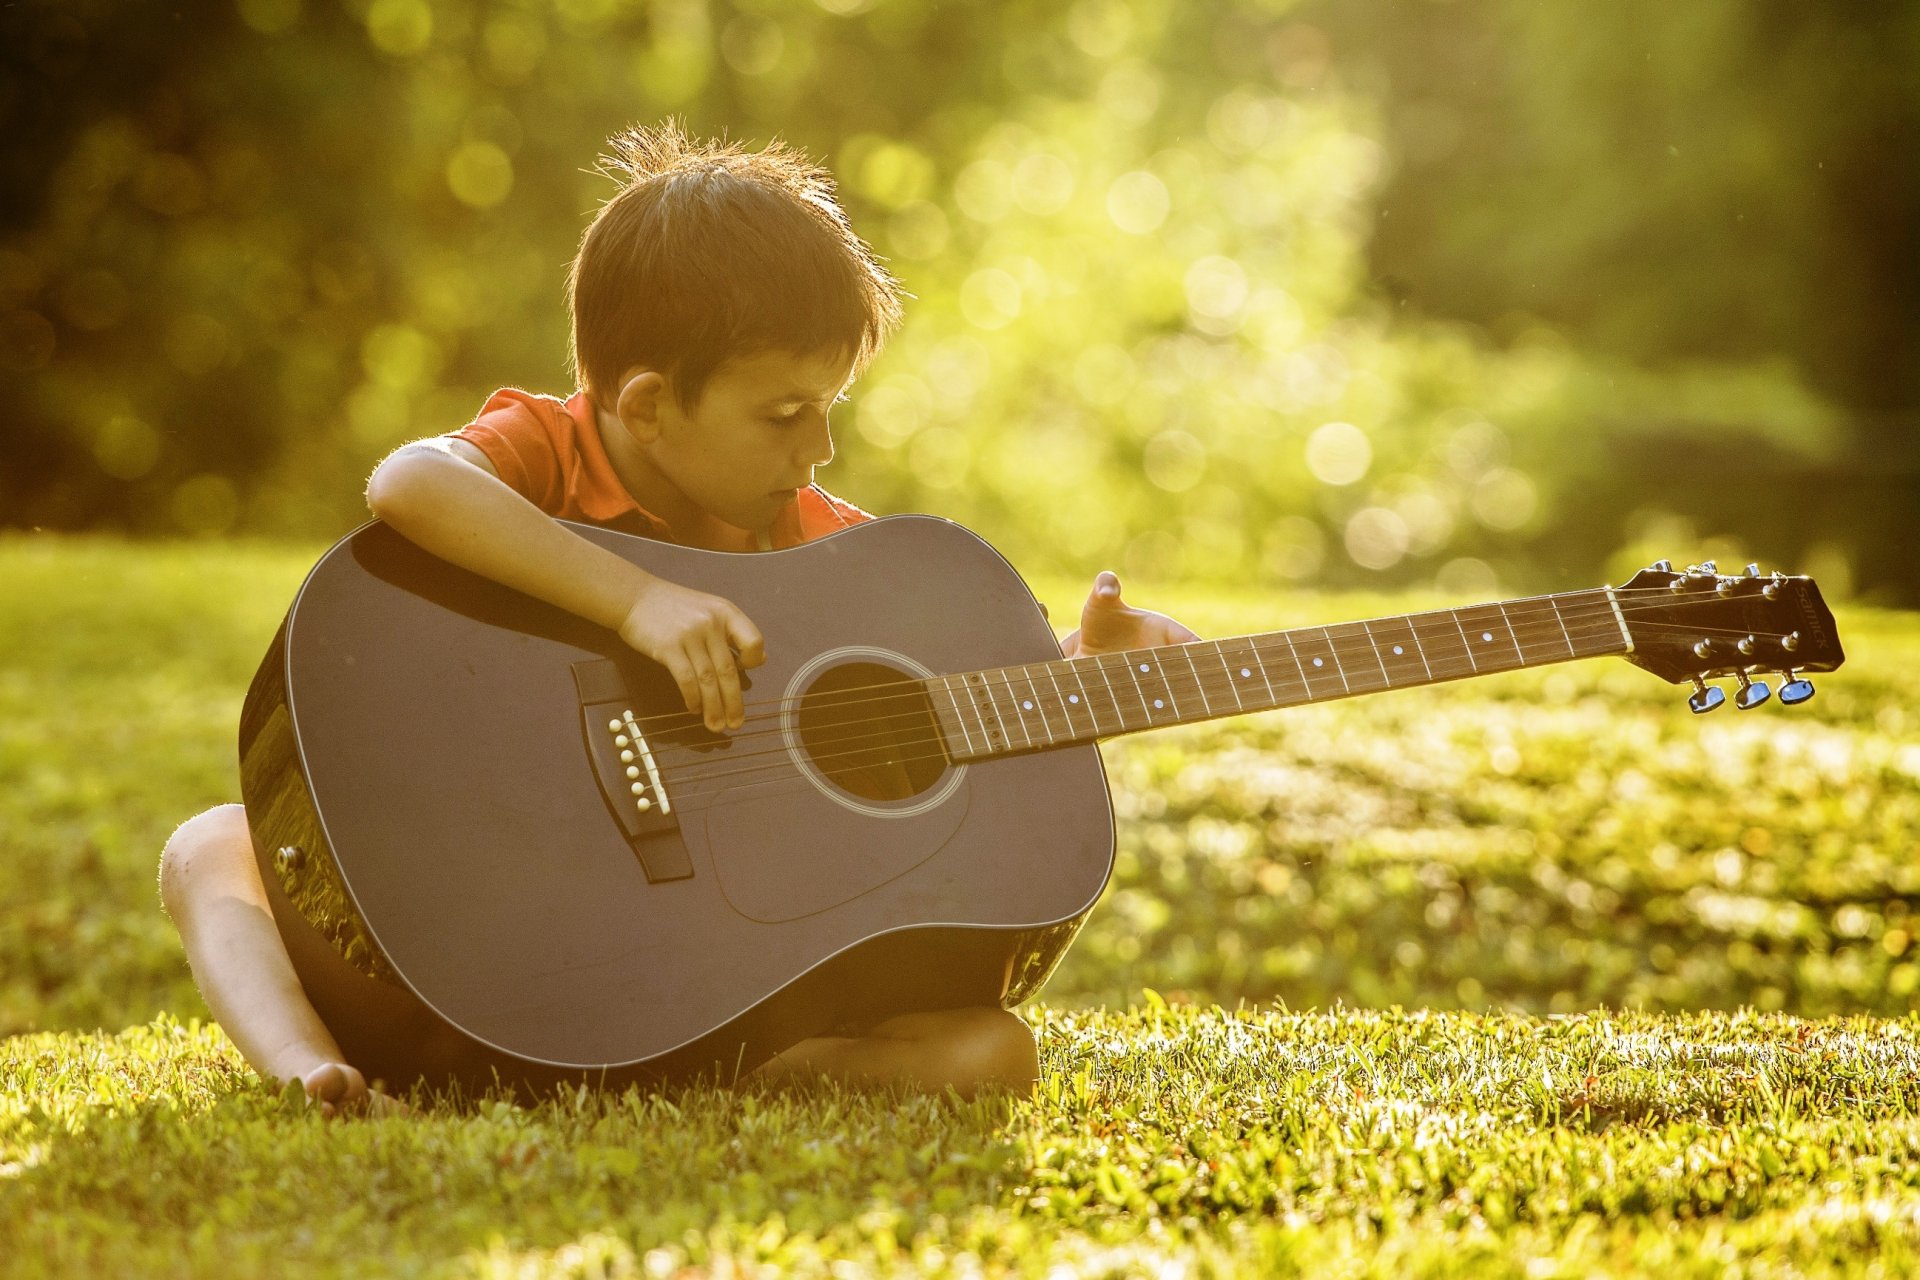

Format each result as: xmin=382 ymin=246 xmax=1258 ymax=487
xmin=643 ymin=351 xmax=852 ymax=530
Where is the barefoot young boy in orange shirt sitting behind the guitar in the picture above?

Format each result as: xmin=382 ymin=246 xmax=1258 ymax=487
xmin=159 ymin=125 xmax=1194 ymax=1115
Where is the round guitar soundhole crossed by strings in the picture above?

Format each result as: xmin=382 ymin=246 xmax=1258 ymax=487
xmin=797 ymin=662 xmax=947 ymax=800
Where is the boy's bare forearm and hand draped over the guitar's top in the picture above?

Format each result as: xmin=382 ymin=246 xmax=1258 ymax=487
xmin=367 ymin=438 xmax=764 ymax=733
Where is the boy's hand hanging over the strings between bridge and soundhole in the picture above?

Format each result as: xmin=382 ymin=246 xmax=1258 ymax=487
xmin=620 ymin=578 xmax=766 ymax=733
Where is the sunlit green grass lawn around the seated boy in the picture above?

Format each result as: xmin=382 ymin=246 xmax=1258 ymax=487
xmin=0 ymin=537 xmax=1920 ymax=1276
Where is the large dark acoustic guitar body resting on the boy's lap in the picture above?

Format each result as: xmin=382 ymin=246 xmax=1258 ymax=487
xmin=240 ymin=516 xmax=1114 ymax=1096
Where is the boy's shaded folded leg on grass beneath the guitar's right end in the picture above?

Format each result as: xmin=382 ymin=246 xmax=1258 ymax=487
xmin=747 ymin=1007 xmax=1041 ymax=1098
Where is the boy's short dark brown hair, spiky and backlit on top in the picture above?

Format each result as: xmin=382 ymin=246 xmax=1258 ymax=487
xmin=570 ymin=121 xmax=902 ymax=413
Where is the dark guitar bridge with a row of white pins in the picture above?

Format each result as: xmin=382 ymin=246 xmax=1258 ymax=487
xmin=572 ymin=660 xmax=693 ymax=883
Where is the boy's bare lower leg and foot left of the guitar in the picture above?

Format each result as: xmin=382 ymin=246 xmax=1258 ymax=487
xmin=159 ymin=804 xmax=393 ymax=1115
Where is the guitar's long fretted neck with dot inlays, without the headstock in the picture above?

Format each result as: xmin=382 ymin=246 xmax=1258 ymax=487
xmin=925 ymin=587 xmax=1634 ymax=762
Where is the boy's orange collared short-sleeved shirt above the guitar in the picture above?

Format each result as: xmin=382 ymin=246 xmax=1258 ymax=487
xmin=453 ymin=388 xmax=874 ymax=551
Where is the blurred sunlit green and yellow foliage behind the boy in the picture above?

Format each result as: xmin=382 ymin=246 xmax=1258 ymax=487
xmin=0 ymin=0 xmax=1920 ymax=599
